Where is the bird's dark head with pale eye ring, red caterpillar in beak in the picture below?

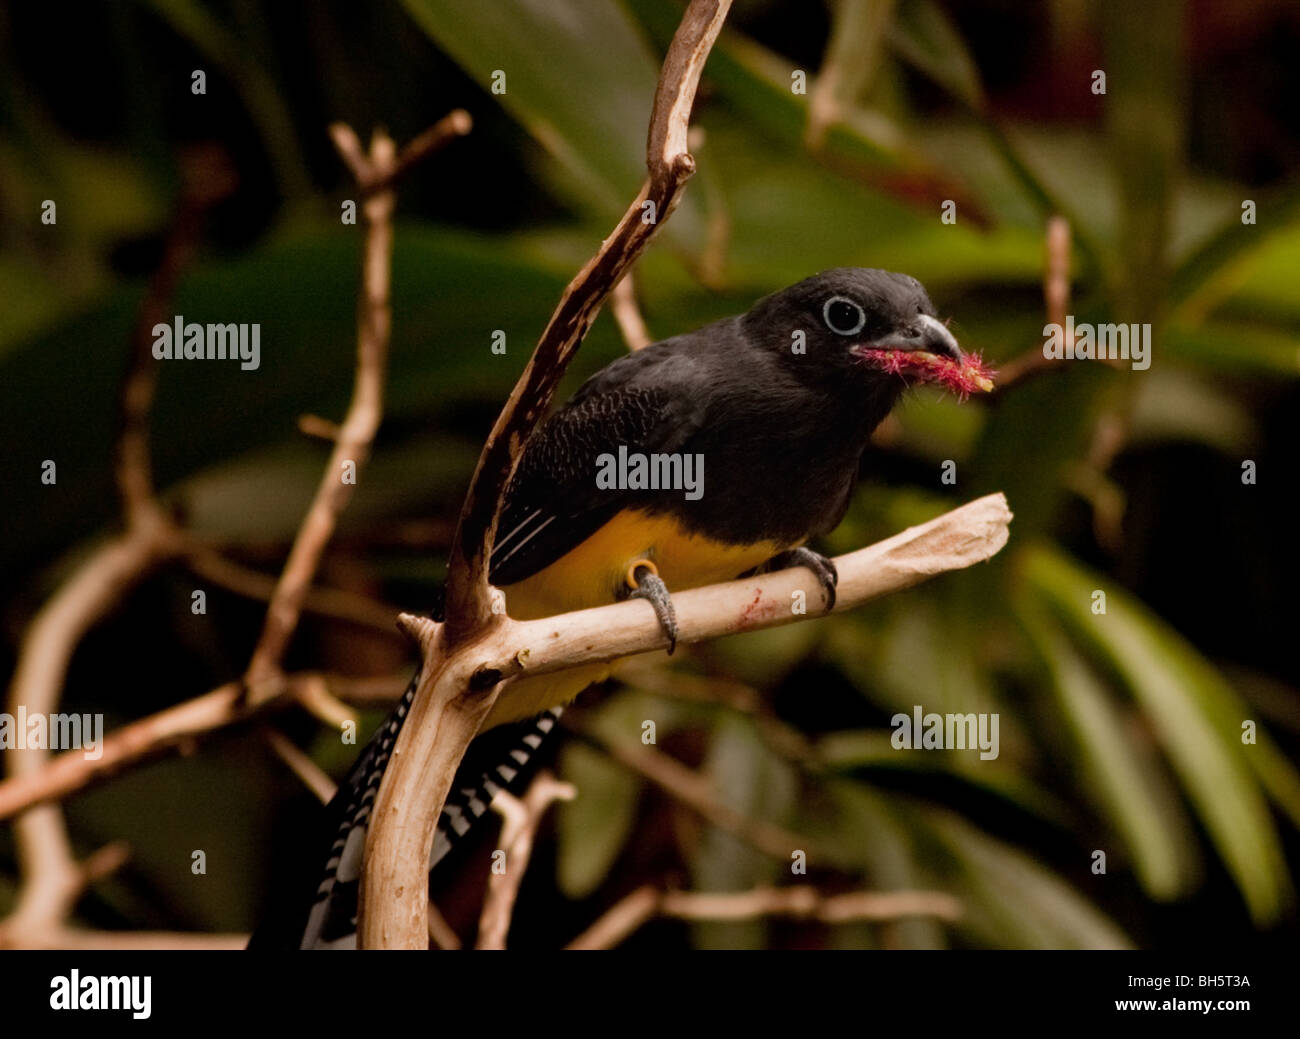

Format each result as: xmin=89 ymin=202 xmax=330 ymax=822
xmin=744 ymin=267 xmax=993 ymax=398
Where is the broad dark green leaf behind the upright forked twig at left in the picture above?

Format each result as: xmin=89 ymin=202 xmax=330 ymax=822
xmin=0 ymin=224 xmax=608 ymax=571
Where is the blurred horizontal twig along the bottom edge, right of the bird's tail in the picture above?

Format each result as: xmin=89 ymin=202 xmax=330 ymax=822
xmin=568 ymin=886 xmax=962 ymax=949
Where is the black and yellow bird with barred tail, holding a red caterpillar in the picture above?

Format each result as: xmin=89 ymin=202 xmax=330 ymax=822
xmin=255 ymin=268 xmax=992 ymax=948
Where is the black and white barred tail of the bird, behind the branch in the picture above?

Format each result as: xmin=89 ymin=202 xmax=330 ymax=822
xmin=250 ymin=670 xmax=563 ymax=949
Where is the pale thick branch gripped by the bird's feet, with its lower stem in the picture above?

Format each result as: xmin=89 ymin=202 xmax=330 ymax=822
xmin=361 ymin=494 xmax=1011 ymax=948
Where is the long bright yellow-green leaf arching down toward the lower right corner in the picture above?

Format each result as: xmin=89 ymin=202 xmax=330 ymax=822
xmin=1023 ymin=546 xmax=1300 ymax=923
